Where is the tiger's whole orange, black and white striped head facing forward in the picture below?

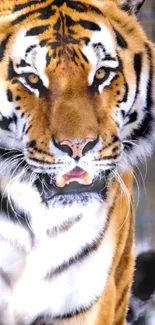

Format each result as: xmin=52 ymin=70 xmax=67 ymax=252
xmin=0 ymin=0 xmax=155 ymax=203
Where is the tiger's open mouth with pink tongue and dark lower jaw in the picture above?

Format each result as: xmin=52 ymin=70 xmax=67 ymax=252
xmin=36 ymin=167 xmax=109 ymax=202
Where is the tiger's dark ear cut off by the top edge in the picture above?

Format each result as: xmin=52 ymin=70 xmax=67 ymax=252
xmin=116 ymin=0 xmax=145 ymax=14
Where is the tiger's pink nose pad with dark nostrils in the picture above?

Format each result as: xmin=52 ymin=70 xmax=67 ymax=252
xmin=53 ymin=137 xmax=99 ymax=159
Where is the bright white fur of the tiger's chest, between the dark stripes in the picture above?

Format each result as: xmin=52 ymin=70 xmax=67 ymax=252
xmin=0 ymin=175 xmax=114 ymax=325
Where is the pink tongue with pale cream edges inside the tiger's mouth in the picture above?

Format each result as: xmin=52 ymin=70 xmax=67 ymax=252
xmin=56 ymin=167 xmax=93 ymax=187
